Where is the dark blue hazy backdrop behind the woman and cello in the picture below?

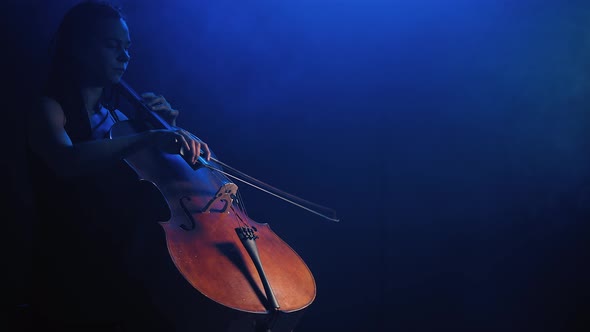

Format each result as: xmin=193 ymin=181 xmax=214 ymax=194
xmin=0 ymin=0 xmax=590 ymax=332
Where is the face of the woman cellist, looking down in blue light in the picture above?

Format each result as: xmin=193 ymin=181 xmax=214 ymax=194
xmin=80 ymin=18 xmax=131 ymax=86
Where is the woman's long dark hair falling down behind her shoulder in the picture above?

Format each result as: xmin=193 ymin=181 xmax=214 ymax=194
xmin=44 ymin=0 xmax=125 ymax=141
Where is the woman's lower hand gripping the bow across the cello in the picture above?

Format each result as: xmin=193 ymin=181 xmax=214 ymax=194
xmin=148 ymin=128 xmax=211 ymax=164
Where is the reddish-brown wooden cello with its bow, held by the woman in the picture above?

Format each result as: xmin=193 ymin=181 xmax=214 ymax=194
xmin=110 ymin=80 xmax=339 ymax=332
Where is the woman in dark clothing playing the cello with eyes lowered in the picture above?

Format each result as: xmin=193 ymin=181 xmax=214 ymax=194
xmin=28 ymin=1 xmax=210 ymax=331
